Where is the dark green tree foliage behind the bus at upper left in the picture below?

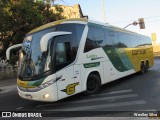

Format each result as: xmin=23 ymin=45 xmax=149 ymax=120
xmin=0 ymin=0 xmax=64 ymax=58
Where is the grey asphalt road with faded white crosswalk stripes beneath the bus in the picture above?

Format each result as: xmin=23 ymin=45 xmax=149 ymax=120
xmin=0 ymin=59 xmax=160 ymax=117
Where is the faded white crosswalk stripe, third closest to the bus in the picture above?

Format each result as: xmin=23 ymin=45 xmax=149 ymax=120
xmin=45 ymin=100 xmax=146 ymax=111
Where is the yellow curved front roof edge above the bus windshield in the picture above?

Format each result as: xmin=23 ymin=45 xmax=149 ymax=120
xmin=28 ymin=18 xmax=88 ymax=34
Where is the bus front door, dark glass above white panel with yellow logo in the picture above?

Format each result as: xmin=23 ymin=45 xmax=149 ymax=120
xmin=55 ymin=40 xmax=76 ymax=99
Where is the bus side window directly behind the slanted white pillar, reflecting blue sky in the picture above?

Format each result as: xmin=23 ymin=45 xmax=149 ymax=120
xmin=84 ymin=26 xmax=106 ymax=52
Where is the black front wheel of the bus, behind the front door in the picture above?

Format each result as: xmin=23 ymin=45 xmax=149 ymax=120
xmin=84 ymin=74 xmax=101 ymax=95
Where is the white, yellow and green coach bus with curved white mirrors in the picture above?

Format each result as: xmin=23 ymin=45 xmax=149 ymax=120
xmin=6 ymin=19 xmax=154 ymax=102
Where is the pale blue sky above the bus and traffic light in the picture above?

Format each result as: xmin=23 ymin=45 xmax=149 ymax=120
xmin=55 ymin=0 xmax=160 ymax=43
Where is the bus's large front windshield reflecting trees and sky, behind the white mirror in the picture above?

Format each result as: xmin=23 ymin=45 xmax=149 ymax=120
xmin=18 ymin=28 xmax=56 ymax=77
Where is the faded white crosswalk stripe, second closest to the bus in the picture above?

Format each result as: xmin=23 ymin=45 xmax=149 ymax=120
xmin=36 ymin=94 xmax=138 ymax=107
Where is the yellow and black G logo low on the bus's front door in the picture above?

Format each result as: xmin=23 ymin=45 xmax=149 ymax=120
xmin=61 ymin=82 xmax=79 ymax=95
